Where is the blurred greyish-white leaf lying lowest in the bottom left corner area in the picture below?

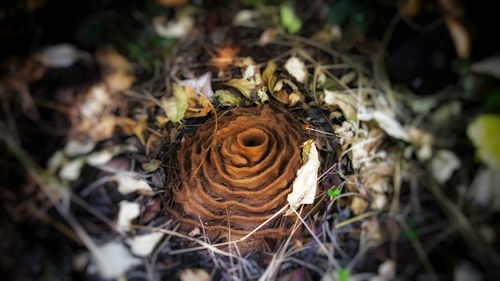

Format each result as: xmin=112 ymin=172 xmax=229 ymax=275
xmin=92 ymin=241 xmax=141 ymax=279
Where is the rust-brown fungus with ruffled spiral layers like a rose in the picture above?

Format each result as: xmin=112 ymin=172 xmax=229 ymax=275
xmin=171 ymin=105 xmax=305 ymax=252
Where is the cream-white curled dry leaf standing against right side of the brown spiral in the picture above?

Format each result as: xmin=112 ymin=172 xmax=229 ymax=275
xmin=287 ymin=140 xmax=320 ymax=214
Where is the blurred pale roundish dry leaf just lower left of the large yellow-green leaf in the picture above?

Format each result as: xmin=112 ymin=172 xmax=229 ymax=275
xmin=430 ymin=149 xmax=460 ymax=183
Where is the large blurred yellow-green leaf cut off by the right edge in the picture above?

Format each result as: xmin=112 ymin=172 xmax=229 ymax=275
xmin=467 ymin=114 xmax=500 ymax=170
